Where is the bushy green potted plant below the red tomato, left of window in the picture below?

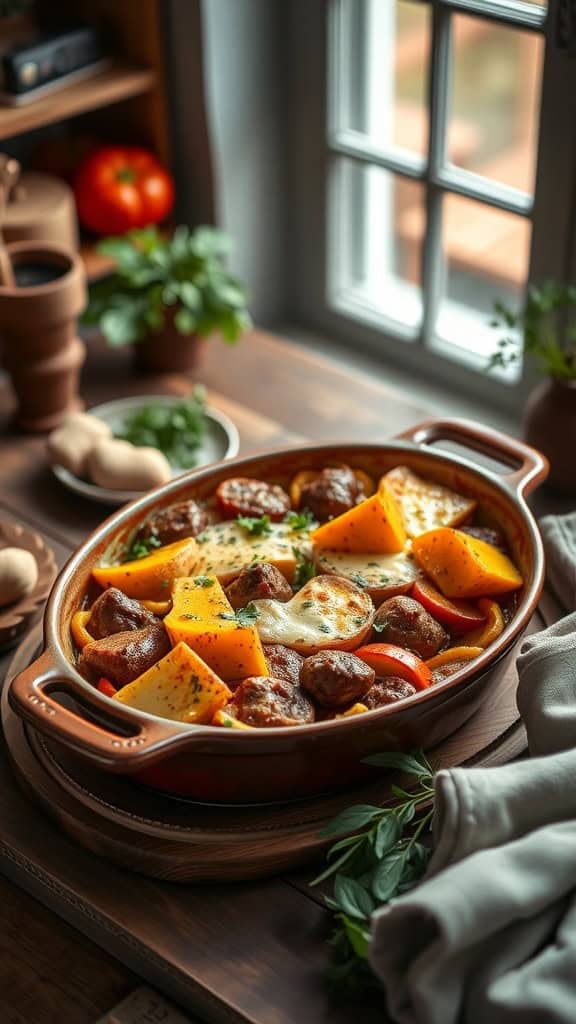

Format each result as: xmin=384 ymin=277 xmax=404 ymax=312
xmin=83 ymin=226 xmax=252 ymax=373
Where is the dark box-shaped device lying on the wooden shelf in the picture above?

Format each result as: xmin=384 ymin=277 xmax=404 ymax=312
xmin=0 ymin=28 xmax=109 ymax=106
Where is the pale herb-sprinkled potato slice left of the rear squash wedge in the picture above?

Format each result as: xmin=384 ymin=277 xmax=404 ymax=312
xmin=195 ymin=522 xmax=307 ymax=585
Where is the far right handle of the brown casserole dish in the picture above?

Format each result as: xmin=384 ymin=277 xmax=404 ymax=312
xmin=395 ymin=420 xmax=549 ymax=497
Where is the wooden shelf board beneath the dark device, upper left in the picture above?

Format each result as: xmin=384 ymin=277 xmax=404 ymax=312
xmin=0 ymin=63 xmax=157 ymax=139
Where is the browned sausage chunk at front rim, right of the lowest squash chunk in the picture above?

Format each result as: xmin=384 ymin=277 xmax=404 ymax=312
xmin=228 ymin=676 xmax=314 ymax=729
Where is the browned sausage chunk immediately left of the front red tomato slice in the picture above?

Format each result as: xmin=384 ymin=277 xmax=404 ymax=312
xmin=300 ymin=650 xmax=376 ymax=708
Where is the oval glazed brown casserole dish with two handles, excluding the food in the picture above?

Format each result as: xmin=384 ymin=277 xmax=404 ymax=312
xmin=8 ymin=420 xmax=547 ymax=803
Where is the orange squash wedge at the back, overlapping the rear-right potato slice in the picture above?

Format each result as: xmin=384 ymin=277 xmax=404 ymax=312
xmin=311 ymin=486 xmax=406 ymax=554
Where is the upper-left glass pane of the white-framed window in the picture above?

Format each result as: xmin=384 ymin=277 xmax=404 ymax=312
xmin=335 ymin=0 xmax=430 ymax=156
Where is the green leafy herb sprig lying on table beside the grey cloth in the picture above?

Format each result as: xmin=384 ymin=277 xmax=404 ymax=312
xmin=311 ymin=751 xmax=434 ymax=995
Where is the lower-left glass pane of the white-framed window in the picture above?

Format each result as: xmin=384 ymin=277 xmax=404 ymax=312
xmin=330 ymin=158 xmax=424 ymax=328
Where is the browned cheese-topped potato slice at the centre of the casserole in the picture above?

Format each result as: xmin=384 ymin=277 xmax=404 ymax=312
xmin=253 ymin=575 xmax=374 ymax=654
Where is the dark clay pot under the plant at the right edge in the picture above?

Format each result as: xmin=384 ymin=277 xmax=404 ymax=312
xmin=524 ymin=377 xmax=576 ymax=495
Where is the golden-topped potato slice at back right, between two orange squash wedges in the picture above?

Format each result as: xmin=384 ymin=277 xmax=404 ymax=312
xmin=379 ymin=466 xmax=478 ymax=537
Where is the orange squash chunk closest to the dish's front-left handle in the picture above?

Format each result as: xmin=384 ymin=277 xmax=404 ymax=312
xmin=113 ymin=643 xmax=232 ymax=725
